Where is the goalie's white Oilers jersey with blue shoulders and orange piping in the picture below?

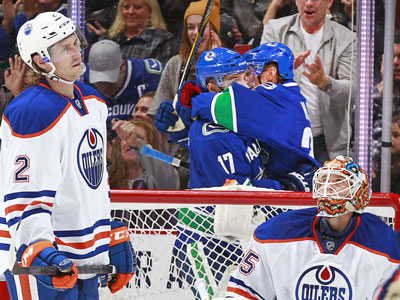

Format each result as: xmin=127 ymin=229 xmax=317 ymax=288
xmin=227 ymin=208 xmax=400 ymax=300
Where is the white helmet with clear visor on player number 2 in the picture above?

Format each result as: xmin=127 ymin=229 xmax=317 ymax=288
xmin=17 ymin=12 xmax=87 ymax=84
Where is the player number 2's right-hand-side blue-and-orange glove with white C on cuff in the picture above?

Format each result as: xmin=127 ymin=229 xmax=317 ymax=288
xmin=107 ymin=221 xmax=137 ymax=293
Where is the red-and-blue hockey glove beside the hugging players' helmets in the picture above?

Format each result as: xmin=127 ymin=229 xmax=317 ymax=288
xmin=175 ymin=80 xmax=203 ymax=126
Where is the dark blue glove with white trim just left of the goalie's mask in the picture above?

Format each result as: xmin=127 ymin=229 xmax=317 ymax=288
xmin=278 ymin=164 xmax=314 ymax=192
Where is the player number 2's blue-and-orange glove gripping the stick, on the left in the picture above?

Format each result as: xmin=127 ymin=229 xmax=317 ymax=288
xmin=17 ymin=241 xmax=78 ymax=290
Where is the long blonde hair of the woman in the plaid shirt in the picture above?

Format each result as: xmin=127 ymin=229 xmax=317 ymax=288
xmin=108 ymin=0 xmax=167 ymax=38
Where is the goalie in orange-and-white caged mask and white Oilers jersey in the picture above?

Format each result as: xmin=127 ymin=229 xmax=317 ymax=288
xmin=227 ymin=156 xmax=400 ymax=300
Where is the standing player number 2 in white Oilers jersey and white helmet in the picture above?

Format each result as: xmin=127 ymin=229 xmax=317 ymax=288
xmin=0 ymin=12 xmax=136 ymax=300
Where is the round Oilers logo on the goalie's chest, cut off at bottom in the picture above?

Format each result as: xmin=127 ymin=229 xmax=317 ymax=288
xmin=296 ymin=265 xmax=353 ymax=300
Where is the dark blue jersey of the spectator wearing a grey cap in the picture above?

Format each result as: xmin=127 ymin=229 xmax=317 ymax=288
xmin=105 ymin=58 xmax=163 ymax=126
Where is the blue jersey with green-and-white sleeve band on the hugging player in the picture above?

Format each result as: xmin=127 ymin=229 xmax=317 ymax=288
xmin=192 ymin=81 xmax=319 ymax=178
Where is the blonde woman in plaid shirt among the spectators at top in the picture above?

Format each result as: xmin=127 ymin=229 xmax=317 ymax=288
xmin=87 ymin=0 xmax=177 ymax=63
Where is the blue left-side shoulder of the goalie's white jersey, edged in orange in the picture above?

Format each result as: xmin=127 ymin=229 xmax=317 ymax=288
xmin=254 ymin=207 xmax=317 ymax=242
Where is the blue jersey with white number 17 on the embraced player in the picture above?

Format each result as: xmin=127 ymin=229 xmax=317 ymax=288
xmin=189 ymin=120 xmax=281 ymax=189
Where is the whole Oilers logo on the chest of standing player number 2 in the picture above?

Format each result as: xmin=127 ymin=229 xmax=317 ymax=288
xmin=78 ymin=128 xmax=104 ymax=189
